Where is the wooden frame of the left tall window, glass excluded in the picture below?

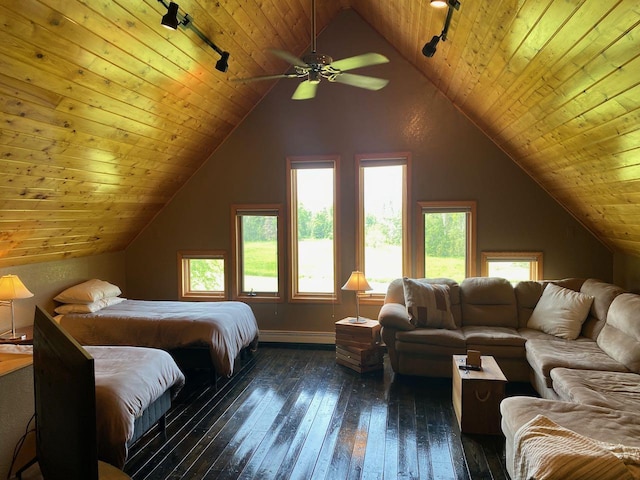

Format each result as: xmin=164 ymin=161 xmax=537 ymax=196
xmin=286 ymin=155 xmax=341 ymax=303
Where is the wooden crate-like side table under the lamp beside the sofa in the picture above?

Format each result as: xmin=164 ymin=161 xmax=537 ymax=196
xmin=336 ymin=317 xmax=385 ymax=373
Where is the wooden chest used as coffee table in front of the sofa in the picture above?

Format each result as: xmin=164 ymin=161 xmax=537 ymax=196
xmin=453 ymin=355 xmax=507 ymax=435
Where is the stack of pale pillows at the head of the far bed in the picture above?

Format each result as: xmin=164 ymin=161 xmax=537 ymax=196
xmin=53 ymin=279 xmax=124 ymax=315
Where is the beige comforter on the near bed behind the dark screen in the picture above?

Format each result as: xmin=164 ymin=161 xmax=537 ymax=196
xmin=85 ymin=347 xmax=185 ymax=468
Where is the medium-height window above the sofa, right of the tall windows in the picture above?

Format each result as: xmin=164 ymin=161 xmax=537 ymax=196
xmin=418 ymin=202 xmax=476 ymax=282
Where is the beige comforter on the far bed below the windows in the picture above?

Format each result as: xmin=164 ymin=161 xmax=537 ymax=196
xmin=60 ymin=300 xmax=258 ymax=376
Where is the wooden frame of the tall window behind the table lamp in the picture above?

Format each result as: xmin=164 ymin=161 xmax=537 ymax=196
xmin=354 ymin=152 xmax=412 ymax=305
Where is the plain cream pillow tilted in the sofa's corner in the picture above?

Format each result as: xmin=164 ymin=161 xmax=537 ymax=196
xmin=527 ymin=283 xmax=593 ymax=340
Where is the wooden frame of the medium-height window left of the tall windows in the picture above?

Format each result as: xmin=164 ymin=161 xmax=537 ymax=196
xmin=231 ymin=203 xmax=286 ymax=303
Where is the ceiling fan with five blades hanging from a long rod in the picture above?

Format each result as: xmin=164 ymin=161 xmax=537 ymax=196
xmin=236 ymin=0 xmax=389 ymax=100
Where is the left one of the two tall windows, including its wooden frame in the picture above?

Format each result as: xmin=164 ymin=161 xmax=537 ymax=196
xmin=287 ymin=156 xmax=339 ymax=301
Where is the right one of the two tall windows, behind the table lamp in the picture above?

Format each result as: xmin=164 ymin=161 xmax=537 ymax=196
xmin=355 ymin=153 xmax=411 ymax=301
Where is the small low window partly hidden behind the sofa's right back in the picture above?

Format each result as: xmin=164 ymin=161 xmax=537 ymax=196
xmin=481 ymin=252 xmax=544 ymax=285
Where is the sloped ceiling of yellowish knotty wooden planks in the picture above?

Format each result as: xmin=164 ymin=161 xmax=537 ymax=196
xmin=0 ymin=0 xmax=640 ymax=267
